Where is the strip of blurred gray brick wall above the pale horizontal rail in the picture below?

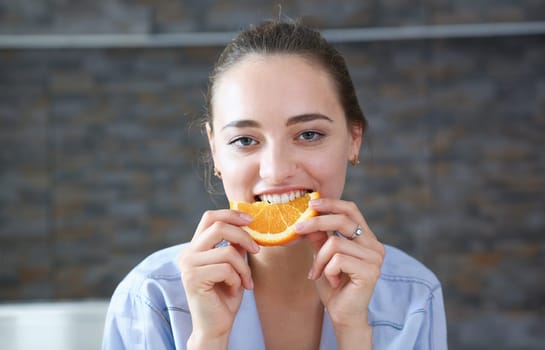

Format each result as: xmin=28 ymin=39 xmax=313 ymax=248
xmin=0 ymin=0 xmax=545 ymax=34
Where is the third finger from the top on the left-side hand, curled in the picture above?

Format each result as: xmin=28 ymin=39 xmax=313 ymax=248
xmin=191 ymin=246 xmax=253 ymax=289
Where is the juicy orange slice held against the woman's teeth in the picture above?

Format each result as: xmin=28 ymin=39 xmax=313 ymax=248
xmin=229 ymin=192 xmax=320 ymax=246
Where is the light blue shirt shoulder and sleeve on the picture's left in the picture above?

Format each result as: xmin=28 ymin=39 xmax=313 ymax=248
xmin=103 ymin=244 xmax=191 ymax=349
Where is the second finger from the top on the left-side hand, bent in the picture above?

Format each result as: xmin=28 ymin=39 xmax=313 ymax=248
xmin=192 ymin=221 xmax=259 ymax=253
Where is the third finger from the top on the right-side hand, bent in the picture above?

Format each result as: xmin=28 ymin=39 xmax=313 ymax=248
xmin=309 ymin=236 xmax=384 ymax=279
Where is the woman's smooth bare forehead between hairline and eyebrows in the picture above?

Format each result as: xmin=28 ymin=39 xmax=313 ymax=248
xmin=212 ymin=54 xmax=343 ymax=124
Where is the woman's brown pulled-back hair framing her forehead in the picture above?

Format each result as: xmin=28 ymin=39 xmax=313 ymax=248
xmin=205 ymin=21 xmax=367 ymax=133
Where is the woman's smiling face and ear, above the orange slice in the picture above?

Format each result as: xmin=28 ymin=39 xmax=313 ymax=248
xmin=208 ymin=55 xmax=361 ymax=202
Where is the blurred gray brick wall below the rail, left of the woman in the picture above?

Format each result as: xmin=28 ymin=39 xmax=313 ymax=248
xmin=0 ymin=45 xmax=218 ymax=299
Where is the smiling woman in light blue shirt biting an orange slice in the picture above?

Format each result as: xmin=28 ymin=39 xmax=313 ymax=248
xmin=103 ymin=22 xmax=446 ymax=349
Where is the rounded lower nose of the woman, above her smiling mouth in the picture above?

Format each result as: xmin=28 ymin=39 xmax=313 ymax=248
xmin=259 ymin=143 xmax=297 ymax=185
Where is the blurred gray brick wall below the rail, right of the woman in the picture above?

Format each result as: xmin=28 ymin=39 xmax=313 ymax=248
xmin=344 ymin=37 xmax=545 ymax=349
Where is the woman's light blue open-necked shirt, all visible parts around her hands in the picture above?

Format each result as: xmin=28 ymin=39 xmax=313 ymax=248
xmin=102 ymin=244 xmax=447 ymax=350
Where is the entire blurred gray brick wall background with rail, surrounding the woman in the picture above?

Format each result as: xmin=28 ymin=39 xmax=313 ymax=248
xmin=0 ymin=0 xmax=545 ymax=350
